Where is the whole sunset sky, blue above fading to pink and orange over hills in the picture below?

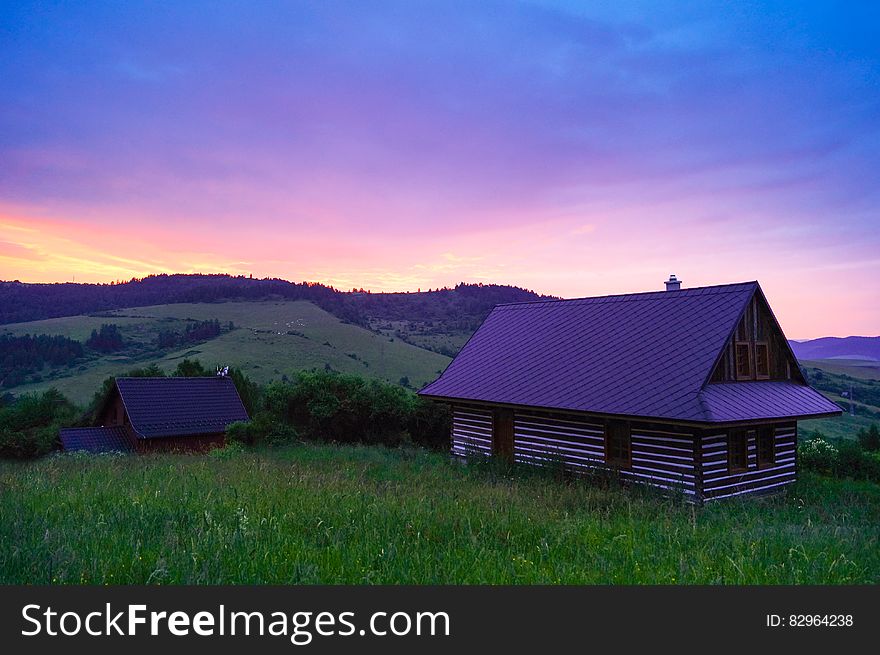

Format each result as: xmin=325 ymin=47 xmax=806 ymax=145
xmin=0 ymin=2 xmax=880 ymax=337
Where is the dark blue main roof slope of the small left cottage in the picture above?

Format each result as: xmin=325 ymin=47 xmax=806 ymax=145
xmin=116 ymin=376 xmax=248 ymax=438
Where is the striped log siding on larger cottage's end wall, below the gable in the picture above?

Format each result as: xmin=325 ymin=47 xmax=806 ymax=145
xmin=701 ymin=423 xmax=797 ymax=500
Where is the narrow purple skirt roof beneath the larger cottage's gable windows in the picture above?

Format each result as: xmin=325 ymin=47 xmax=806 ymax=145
xmin=700 ymin=381 xmax=840 ymax=422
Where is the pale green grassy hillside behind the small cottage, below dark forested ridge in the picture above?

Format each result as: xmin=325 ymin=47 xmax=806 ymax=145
xmin=0 ymin=301 xmax=450 ymax=403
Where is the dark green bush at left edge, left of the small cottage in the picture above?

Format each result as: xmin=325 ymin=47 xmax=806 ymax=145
xmin=0 ymin=389 xmax=77 ymax=458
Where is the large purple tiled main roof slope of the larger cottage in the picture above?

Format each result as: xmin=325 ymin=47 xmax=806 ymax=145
xmin=420 ymin=282 xmax=844 ymax=422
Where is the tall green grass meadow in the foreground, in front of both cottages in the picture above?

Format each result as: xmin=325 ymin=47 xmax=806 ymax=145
xmin=0 ymin=445 xmax=880 ymax=584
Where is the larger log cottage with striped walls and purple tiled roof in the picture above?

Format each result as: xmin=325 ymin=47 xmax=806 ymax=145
xmin=419 ymin=276 xmax=841 ymax=502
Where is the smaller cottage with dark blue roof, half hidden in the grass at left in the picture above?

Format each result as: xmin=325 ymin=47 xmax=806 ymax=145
xmin=61 ymin=376 xmax=248 ymax=453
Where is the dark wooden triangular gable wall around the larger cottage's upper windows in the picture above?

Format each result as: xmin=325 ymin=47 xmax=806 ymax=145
xmin=710 ymin=294 xmax=804 ymax=382
